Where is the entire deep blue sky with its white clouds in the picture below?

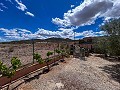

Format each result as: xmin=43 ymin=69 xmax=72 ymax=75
xmin=0 ymin=0 xmax=120 ymax=42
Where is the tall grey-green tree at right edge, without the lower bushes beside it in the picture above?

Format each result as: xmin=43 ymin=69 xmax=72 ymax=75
xmin=101 ymin=18 xmax=120 ymax=56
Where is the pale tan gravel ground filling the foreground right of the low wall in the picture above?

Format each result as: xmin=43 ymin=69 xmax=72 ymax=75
xmin=5 ymin=55 xmax=120 ymax=90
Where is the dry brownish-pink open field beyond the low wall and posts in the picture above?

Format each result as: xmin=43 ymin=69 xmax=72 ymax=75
xmin=0 ymin=42 xmax=58 ymax=66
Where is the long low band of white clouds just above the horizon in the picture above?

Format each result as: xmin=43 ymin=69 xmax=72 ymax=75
xmin=0 ymin=28 xmax=105 ymax=41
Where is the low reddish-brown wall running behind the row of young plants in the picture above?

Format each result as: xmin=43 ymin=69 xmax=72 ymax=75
xmin=0 ymin=55 xmax=63 ymax=88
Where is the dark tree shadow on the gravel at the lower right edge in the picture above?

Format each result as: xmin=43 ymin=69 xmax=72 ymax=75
xmin=100 ymin=64 xmax=120 ymax=83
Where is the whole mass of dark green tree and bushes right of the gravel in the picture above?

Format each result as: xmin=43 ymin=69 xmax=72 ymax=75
xmin=95 ymin=18 xmax=120 ymax=56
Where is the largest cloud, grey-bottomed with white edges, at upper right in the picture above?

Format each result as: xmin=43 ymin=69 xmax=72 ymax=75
xmin=52 ymin=0 xmax=120 ymax=27
